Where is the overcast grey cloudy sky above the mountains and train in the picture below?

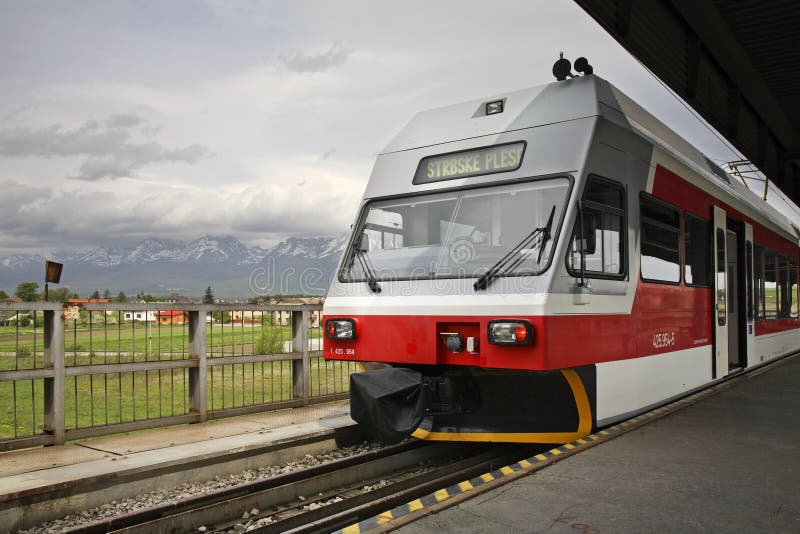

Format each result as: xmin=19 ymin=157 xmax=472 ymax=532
xmin=0 ymin=0 xmax=788 ymax=256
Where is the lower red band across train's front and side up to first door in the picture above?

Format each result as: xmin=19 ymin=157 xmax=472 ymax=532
xmin=324 ymin=282 xmax=712 ymax=370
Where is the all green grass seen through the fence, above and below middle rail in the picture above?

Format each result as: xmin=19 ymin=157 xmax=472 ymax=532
xmin=0 ymin=322 xmax=355 ymax=439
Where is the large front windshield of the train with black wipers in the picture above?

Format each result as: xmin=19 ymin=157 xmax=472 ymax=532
xmin=341 ymin=178 xmax=570 ymax=286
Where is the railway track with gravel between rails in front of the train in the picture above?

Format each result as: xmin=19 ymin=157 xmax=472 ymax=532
xmin=67 ymin=442 xmax=531 ymax=534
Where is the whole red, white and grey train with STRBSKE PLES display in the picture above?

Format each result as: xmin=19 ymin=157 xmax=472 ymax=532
xmin=324 ymin=59 xmax=800 ymax=443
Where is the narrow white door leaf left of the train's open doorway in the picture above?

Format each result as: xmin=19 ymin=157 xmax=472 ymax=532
xmin=711 ymin=206 xmax=729 ymax=379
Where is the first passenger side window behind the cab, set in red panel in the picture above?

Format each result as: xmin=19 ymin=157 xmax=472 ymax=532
xmin=639 ymin=193 xmax=681 ymax=284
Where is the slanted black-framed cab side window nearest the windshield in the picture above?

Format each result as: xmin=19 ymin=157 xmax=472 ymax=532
xmin=567 ymin=176 xmax=626 ymax=278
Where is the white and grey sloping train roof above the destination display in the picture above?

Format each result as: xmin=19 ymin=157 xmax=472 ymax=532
xmin=381 ymin=75 xmax=800 ymax=241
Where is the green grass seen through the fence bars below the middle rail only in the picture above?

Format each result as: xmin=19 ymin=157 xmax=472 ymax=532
xmin=0 ymin=358 xmax=355 ymax=439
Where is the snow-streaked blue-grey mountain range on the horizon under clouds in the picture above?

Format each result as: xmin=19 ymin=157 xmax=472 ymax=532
xmin=0 ymin=235 xmax=347 ymax=300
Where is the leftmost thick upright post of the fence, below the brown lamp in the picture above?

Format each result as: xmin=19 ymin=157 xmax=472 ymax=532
xmin=44 ymin=310 xmax=66 ymax=445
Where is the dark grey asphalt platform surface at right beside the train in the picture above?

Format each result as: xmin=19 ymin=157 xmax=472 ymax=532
xmin=397 ymin=356 xmax=800 ymax=534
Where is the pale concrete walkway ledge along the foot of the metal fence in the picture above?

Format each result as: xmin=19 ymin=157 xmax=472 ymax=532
xmin=0 ymin=400 xmax=354 ymax=531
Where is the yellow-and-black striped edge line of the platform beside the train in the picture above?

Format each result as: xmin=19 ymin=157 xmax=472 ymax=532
xmin=334 ymin=358 xmax=800 ymax=534
